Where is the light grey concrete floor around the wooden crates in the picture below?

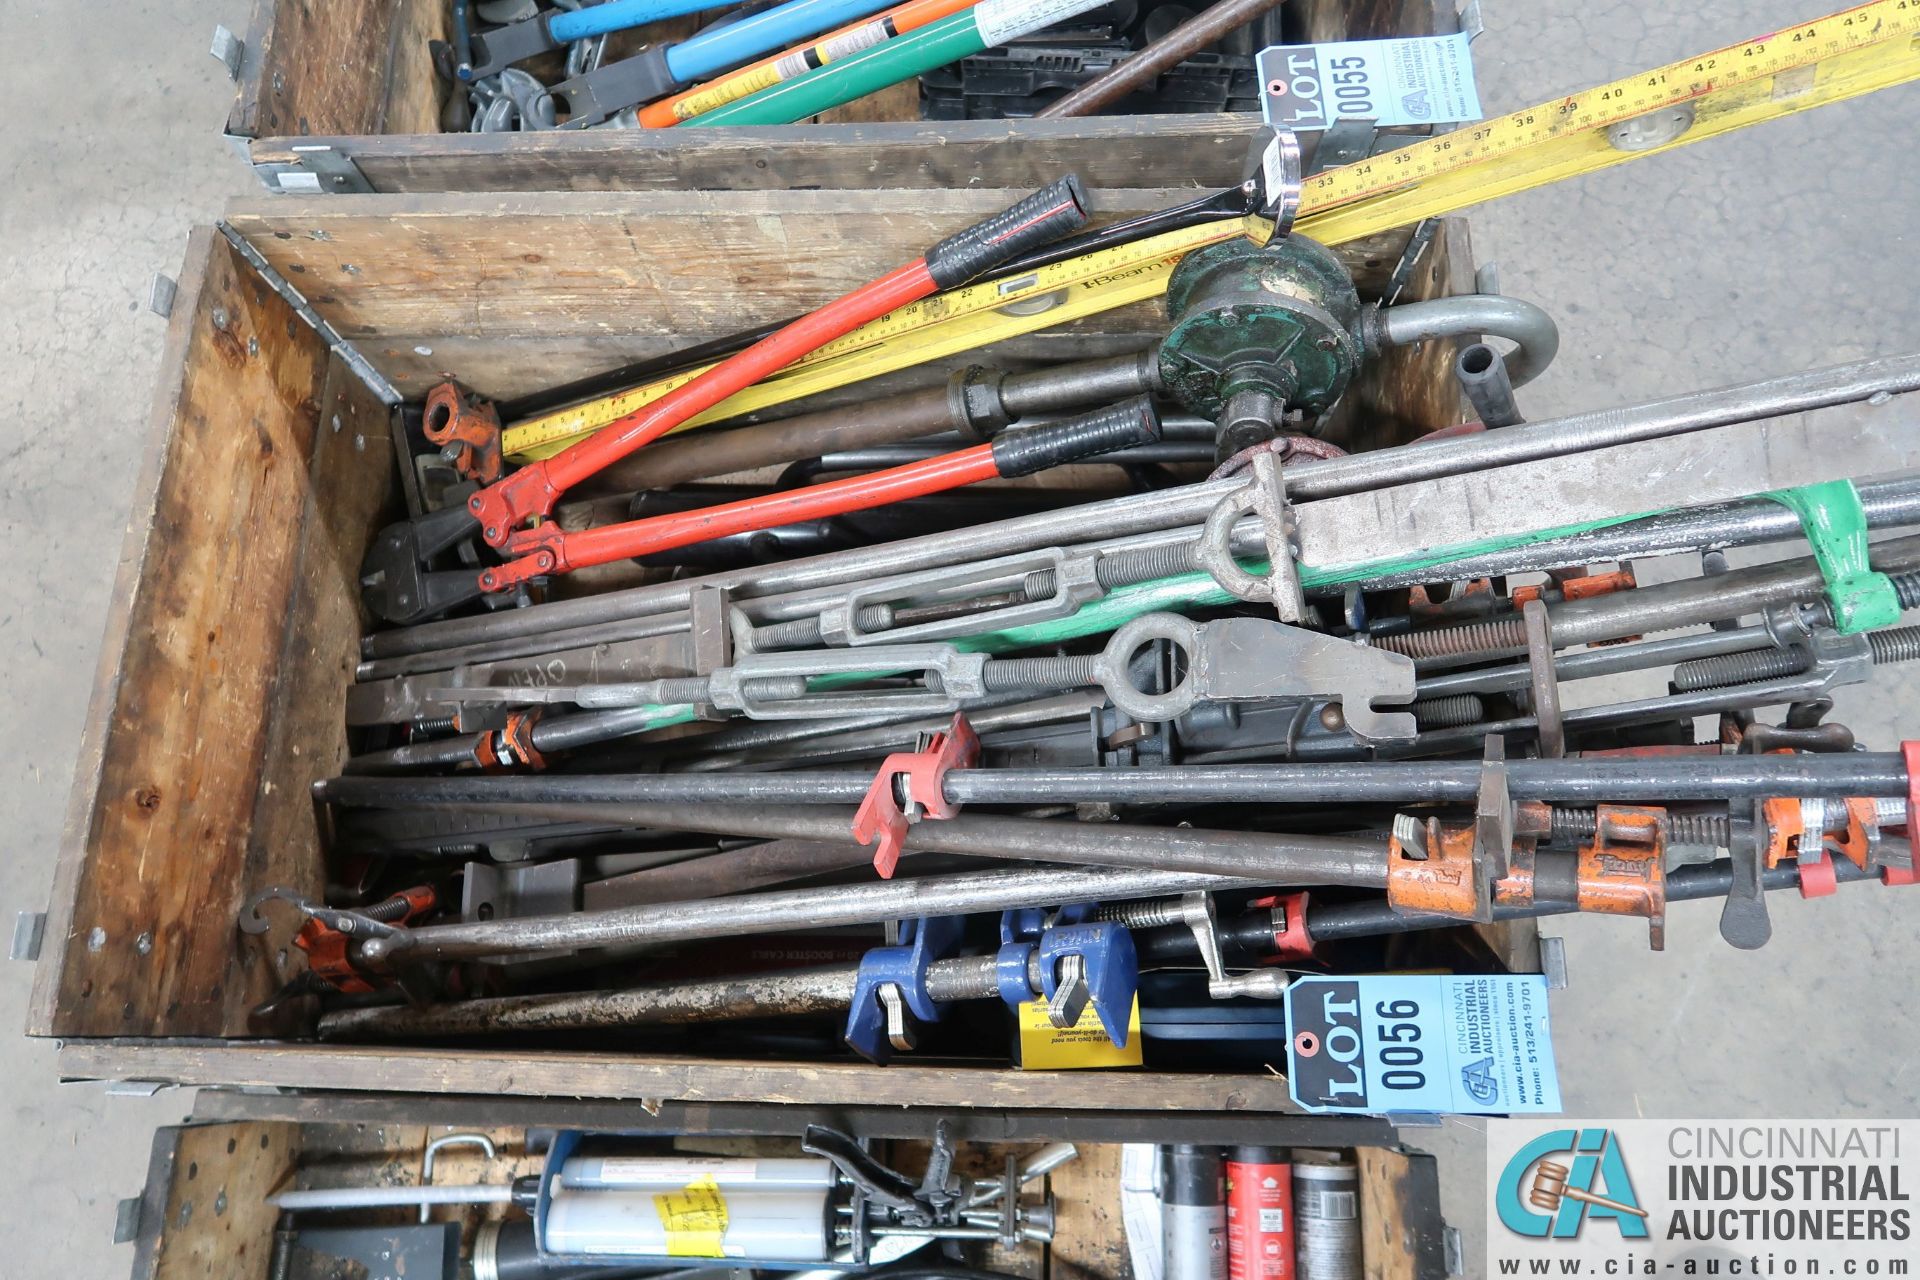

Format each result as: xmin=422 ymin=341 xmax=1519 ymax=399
xmin=0 ymin=0 xmax=1920 ymax=1280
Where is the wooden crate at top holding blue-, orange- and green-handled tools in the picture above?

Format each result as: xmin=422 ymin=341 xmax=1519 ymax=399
xmin=227 ymin=0 xmax=1459 ymax=194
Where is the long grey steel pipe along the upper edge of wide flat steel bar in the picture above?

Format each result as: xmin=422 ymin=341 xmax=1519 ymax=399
xmin=365 ymin=355 xmax=1920 ymax=660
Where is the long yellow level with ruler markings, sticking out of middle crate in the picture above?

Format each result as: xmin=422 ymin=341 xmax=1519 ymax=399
xmin=503 ymin=0 xmax=1920 ymax=461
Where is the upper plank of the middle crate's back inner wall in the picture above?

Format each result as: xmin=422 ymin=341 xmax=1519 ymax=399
xmin=227 ymin=190 xmax=1177 ymax=342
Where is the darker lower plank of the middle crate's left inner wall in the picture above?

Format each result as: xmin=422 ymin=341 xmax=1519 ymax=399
xmin=233 ymin=357 xmax=394 ymax=1036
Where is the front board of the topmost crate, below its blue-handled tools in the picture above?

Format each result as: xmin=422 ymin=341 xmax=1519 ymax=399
xmin=307 ymin=118 xmax=1258 ymax=194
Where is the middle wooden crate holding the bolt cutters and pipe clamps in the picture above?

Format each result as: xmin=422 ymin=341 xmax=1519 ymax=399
xmin=31 ymin=180 xmax=1534 ymax=1111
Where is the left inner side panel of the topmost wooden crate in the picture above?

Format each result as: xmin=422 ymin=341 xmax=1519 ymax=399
xmin=227 ymin=0 xmax=417 ymax=141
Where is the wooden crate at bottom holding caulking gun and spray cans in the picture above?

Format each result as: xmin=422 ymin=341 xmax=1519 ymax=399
xmin=123 ymin=1096 xmax=1448 ymax=1280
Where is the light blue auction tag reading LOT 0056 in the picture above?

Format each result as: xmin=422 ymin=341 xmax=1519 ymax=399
xmin=1286 ymin=973 xmax=1561 ymax=1115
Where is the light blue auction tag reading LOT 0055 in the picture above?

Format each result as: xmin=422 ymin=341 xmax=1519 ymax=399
xmin=1256 ymin=33 xmax=1480 ymax=132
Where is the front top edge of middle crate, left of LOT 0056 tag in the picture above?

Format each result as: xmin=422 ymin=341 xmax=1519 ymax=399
xmin=60 ymin=1040 xmax=1298 ymax=1111
